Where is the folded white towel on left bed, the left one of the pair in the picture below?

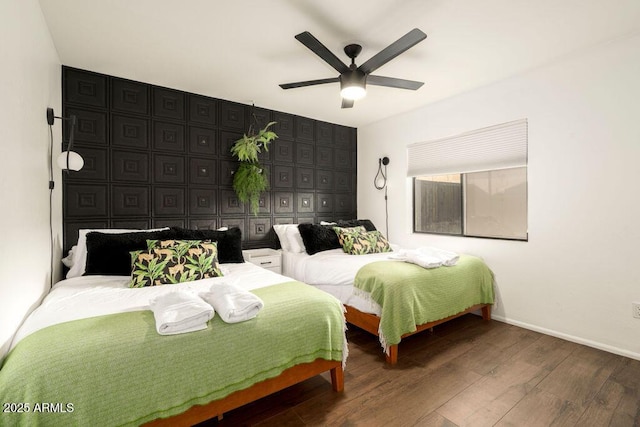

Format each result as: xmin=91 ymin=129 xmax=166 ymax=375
xmin=149 ymin=291 xmax=215 ymax=335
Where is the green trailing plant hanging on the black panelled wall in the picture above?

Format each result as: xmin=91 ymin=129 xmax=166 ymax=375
xmin=231 ymin=122 xmax=278 ymax=215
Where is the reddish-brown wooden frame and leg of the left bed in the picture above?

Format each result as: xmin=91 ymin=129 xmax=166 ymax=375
xmin=144 ymin=359 xmax=344 ymax=426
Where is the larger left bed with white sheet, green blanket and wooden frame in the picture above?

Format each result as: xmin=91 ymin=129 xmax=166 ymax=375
xmin=0 ymin=230 xmax=347 ymax=426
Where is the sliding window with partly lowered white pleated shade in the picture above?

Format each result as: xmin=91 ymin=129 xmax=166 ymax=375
xmin=407 ymin=120 xmax=528 ymax=240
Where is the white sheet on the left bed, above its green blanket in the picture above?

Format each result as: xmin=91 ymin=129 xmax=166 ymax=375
xmin=11 ymin=262 xmax=291 ymax=348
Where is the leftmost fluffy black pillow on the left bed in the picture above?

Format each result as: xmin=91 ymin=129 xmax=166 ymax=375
xmin=84 ymin=230 xmax=176 ymax=276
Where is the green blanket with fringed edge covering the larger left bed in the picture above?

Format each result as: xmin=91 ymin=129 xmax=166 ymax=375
xmin=0 ymin=282 xmax=345 ymax=426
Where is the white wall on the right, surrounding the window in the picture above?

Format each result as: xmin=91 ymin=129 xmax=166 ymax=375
xmin=358 ymin=35 xmax=640 ymax=359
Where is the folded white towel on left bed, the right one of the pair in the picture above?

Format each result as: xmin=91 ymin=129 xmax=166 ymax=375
xmin=200 ymin=283 xmax=264 ymax=323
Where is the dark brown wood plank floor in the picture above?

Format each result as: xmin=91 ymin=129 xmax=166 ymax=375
xmin=202 ymin=314 xmax=640 ymax=427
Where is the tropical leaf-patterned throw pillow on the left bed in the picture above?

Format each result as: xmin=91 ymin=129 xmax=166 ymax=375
xmin=129 ymin=240 xmax=222 ymax=288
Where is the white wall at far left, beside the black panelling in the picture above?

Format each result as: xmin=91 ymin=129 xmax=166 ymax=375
xmin=0 ymin=0 xmax=62 ymax=360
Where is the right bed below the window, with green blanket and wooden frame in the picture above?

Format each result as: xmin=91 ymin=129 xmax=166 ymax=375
xmin=276 ymin=220 xmax=494 ymax=365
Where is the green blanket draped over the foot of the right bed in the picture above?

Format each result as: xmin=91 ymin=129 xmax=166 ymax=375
xmin=354 ymin=255 xmax=493 ymax=352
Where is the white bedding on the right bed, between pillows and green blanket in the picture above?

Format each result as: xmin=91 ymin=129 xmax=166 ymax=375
xmin=282 ymin=249 xmax=398 ymax=316
